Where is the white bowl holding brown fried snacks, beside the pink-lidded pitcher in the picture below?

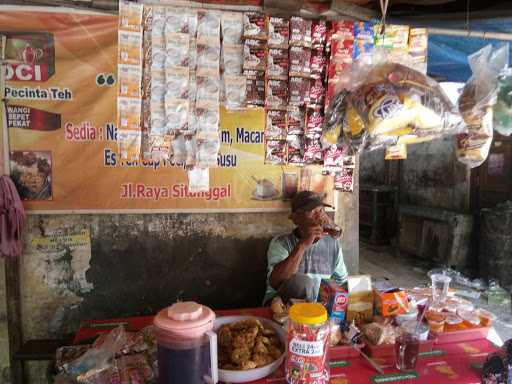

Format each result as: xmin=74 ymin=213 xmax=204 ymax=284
xmin=213 ymin=316 xmax=286 ymax=383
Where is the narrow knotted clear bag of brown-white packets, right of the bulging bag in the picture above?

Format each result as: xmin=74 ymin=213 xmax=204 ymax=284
xmin=457 ymin=45 xmax=508 ymax=168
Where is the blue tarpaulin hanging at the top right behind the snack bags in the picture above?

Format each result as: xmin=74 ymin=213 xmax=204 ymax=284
xmin=425 ymin=17 xmax=512 ymax=82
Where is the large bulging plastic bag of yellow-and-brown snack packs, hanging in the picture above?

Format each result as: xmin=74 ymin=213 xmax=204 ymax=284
xmin=323 ymin=49 xmax=465 ymax=151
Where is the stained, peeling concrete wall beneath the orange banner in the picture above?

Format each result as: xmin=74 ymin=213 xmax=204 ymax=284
xmin=0 ymin=207 xmax=358 ymax=383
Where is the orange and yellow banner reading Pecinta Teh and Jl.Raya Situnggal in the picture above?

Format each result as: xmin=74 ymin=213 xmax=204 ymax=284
xmin=0 ymin=8 xmax=325 ymax=212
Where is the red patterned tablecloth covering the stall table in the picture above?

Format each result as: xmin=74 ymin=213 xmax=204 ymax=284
xmin=74 ymin=308 xmax=496 ymax=384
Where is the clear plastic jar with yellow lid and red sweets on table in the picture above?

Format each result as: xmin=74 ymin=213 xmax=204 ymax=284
xmin=286 ymin=303 xmax=330 ymax=384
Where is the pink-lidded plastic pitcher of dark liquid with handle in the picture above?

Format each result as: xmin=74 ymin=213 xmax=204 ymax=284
xmin=153 ymin=301 xmax=218 ymax=384
